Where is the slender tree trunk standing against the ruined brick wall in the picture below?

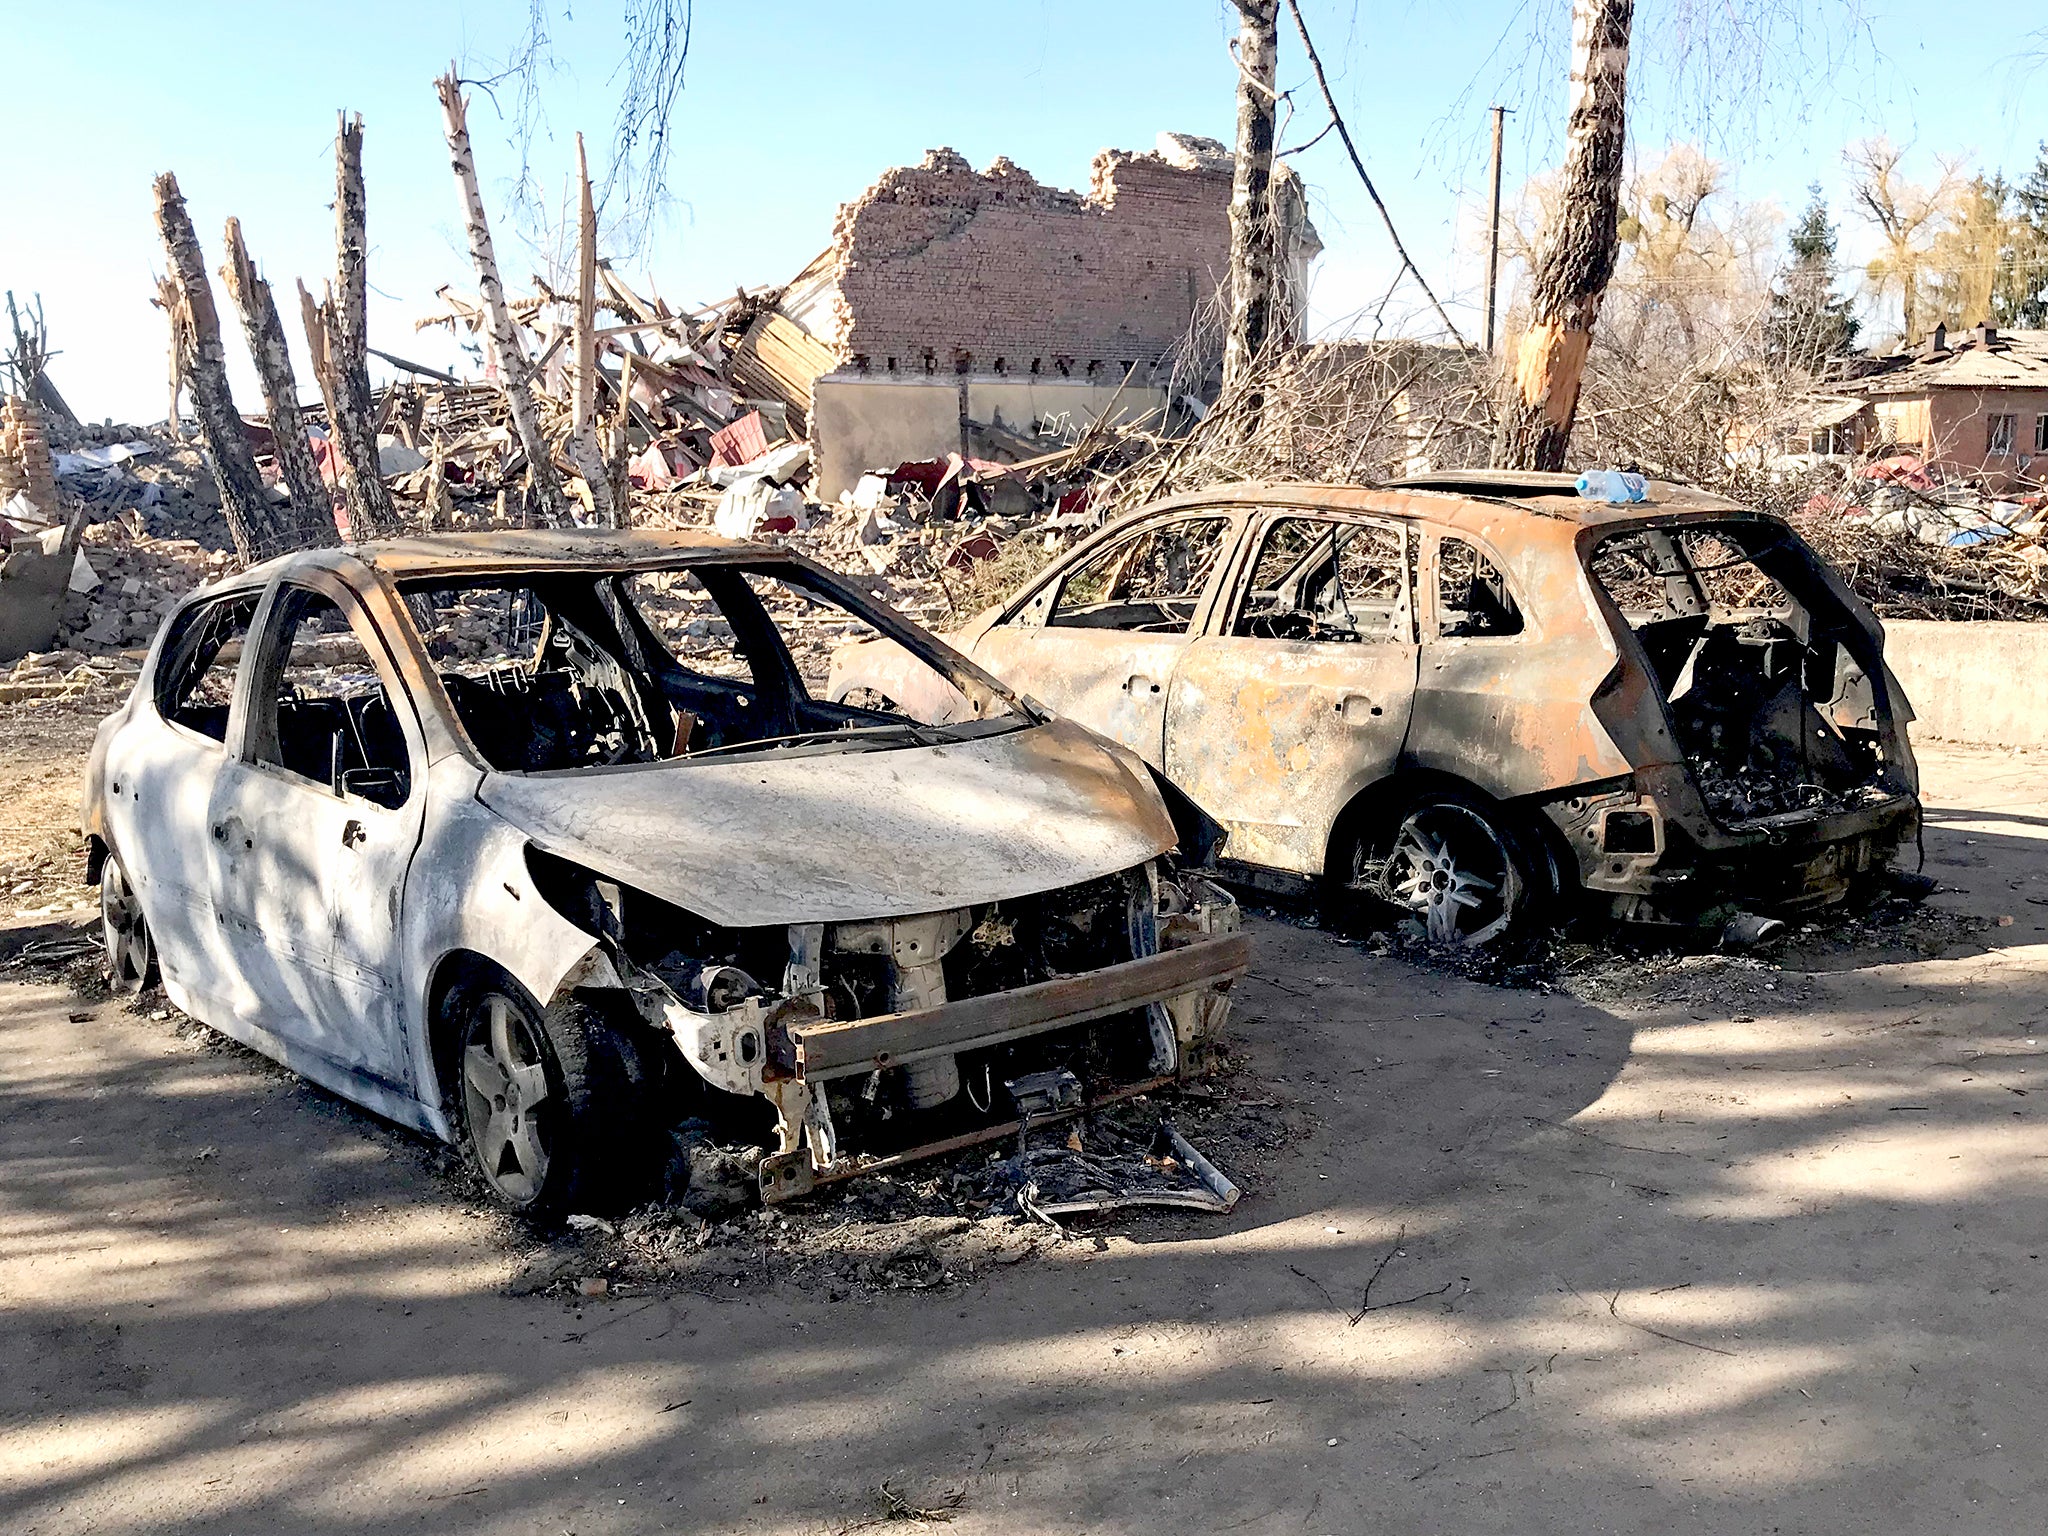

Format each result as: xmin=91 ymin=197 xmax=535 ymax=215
xmin=1223 ymin=0 xmax=1280 ymax=415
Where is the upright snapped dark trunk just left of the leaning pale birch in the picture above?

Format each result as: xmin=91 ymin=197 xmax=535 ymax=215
xmin=324 ymin=115 xmax=399 ymax=541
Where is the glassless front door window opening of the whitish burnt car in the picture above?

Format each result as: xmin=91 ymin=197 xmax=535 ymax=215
xmin=250 ymin=588 xmax=412 ymax=809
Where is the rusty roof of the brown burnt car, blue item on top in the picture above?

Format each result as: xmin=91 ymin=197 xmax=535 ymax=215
xmin=1151 ymin=469 xmax=1753 ymax=530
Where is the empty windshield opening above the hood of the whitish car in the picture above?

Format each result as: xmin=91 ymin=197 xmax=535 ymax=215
xmin=399 ymin=561 xmax=1030 ymax=772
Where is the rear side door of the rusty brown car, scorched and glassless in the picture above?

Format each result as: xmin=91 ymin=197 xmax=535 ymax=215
xmin=1165 ymin=510 xmax=1417 ymax=874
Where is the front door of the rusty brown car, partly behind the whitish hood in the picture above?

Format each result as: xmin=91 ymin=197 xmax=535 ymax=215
xmin=973 ymin=512 xmax=1235 ymax=768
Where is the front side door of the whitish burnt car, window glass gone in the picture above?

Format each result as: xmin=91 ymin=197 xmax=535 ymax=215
xmin=207 ymin=573 xmax=426 ymax=1087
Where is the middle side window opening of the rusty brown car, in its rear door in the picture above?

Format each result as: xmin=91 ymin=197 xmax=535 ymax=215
xmin=1231 ymin=518 xmax=1409 ymax=645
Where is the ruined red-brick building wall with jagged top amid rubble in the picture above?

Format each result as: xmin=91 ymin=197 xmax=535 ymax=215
xmin=731 ymin=133 xmax=1321 ymax=500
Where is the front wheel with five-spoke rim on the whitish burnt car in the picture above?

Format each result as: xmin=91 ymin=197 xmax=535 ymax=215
xmin=442 ymin=975 xmax=662 ymax=1221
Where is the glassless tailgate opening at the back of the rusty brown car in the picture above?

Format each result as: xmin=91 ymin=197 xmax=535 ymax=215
xmin=1589 ymin=522 xmax=1905 ymax=825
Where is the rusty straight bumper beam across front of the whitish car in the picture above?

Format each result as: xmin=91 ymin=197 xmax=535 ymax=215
xmin=788 ymin=934 xmax=1251 ymax=1083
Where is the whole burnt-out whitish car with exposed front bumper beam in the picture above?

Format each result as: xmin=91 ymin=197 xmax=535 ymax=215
xmin=86 ymin=532 xmax=1247 ymax=1212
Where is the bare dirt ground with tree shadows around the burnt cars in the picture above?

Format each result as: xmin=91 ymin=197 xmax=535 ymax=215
xmin=0 ymin=707 xmax=2048 ymax=1536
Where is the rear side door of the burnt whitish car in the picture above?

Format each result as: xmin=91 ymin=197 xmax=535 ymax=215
xmin=102 ymin=588 xmax=262 ymax=1020
